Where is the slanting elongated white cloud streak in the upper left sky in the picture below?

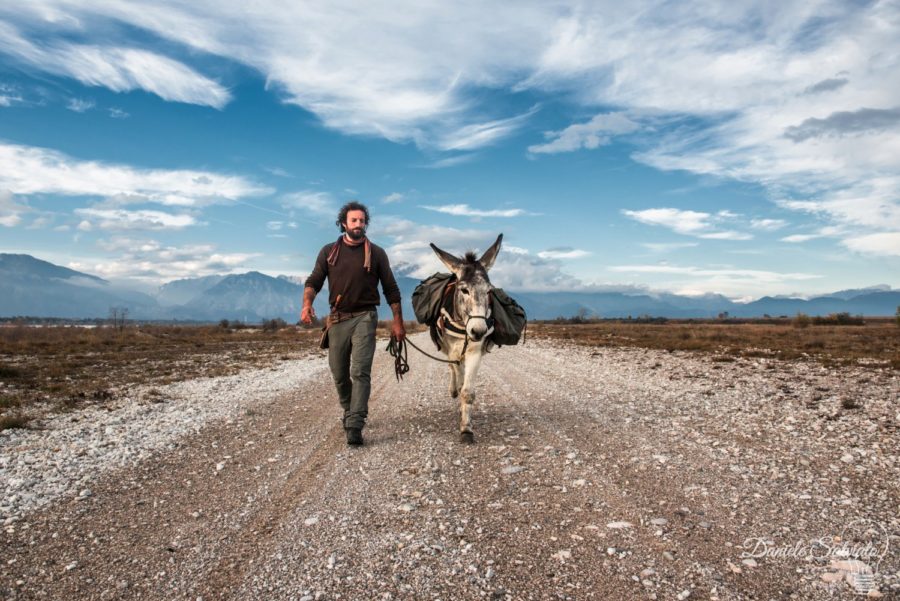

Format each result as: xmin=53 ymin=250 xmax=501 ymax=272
xmin=0 ymin=23 xmax=231 ymax=110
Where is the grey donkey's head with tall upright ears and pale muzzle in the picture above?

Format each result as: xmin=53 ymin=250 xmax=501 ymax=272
xmin=431 ymin=234 xmax=503 ymax=342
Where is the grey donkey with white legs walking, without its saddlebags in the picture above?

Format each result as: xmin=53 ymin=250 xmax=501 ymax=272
xmin=431 ymin=234 xmax=503 ymax=443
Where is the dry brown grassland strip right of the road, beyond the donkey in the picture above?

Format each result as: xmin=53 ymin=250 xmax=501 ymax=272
xmin=528 ymin=319 xmax=900 ymax=369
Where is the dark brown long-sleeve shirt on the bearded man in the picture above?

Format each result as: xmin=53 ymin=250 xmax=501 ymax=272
xmin=304 ymin=238 xmax=400 ymax=312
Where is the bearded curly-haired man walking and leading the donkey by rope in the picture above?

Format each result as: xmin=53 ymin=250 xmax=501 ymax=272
xmin=300 ymin=202 xmax=406 ymax=446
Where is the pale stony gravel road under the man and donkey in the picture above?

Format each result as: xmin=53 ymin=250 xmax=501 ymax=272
xmin=0 ymin=334 xmax=900 ymax=601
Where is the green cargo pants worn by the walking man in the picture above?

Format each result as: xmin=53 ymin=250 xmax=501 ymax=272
xmin=328 ymin=311 xmax=378 ymax=428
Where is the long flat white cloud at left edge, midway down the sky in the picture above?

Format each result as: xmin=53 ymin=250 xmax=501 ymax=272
xmin=0 ymin=142 xmax=272 ymax=207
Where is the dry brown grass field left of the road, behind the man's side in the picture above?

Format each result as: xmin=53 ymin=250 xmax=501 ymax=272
xmin=0 ymin=326 xmax=319 ymax=428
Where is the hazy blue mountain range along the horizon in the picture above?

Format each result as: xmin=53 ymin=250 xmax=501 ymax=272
xmin=0 ymin=254 xmax=900 ymax=323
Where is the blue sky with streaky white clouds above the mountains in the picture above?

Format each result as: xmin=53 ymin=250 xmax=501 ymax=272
xmin=0 ymin=0 xmax=900 ymax=298
